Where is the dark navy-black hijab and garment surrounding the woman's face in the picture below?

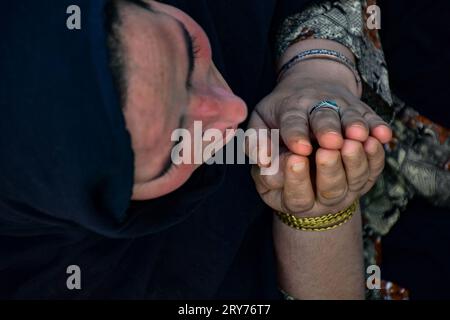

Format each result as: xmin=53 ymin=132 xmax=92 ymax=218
xmin=0 ymin=0 xmax=309 ymax=299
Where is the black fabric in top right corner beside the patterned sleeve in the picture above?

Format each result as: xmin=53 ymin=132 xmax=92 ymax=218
xmin=379 ymin=0 xmax=450 ymax=128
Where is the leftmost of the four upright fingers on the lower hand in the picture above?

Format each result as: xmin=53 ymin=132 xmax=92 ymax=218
xmin=282 ymin=155 xmax=315 ymax=213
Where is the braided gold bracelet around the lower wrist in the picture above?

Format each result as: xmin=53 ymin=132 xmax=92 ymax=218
xmin=275 ymin=200 xmax=358 ymax=231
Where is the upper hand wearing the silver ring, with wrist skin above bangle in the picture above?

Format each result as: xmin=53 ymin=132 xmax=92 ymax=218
xmin=249 ymin=39 xmax=392 ymax=156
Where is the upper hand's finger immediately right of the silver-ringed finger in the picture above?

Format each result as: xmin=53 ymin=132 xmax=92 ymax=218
xmin=341 ymin=105 xmax=369 ymax=142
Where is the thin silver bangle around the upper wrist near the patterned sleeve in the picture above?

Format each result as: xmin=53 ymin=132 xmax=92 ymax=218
xmin=278 ymin=49 xmax=362 ymax=94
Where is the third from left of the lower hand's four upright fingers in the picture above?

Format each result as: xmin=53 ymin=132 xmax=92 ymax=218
xmin=341 ymin=140 xmax=370 ymax=192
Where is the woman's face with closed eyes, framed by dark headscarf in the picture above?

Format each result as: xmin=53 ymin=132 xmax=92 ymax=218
xmin=119 ymin=1 xmax=247 ymax=200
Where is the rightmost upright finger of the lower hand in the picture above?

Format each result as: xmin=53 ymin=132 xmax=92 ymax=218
xmin=361 ymin=137 xmax=385 ymax=194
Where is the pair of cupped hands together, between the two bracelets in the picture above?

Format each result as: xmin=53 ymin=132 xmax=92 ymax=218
xmin=249 ymin=57 xmax=392 ymax=216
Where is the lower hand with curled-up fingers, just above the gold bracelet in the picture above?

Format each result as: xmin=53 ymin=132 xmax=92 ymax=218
xmin=252 ymin=137 xmax=384 ymax=217
